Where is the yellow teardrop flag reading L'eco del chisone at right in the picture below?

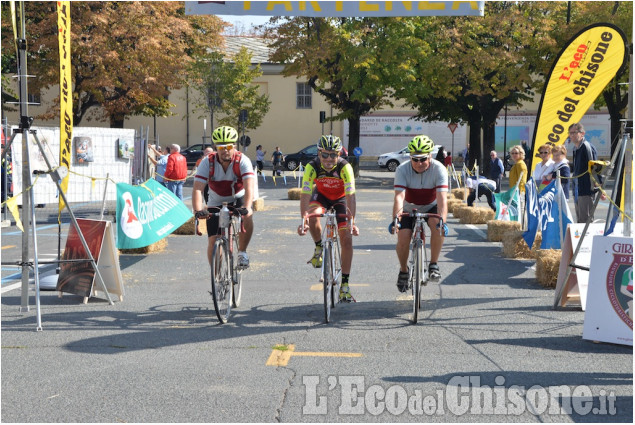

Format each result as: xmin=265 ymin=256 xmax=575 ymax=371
xmin=529 ymin=23 xmax=627 ymax=175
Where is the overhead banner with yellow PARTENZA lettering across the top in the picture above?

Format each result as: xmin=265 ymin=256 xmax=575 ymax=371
xmin=185 ymin=1 xmax=485 ymax=18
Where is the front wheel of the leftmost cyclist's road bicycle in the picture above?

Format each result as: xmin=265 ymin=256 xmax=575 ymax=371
xmin=212 ymin=238 xmax=233 ymax=323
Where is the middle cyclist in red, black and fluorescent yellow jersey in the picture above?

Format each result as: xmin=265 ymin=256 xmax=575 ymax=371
xmin=298 ymin=135 xmax=359 ymax=302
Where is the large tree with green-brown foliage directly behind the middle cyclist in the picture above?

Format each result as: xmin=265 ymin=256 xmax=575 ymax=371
xmin=266 ymin=17 xmax=404 ymax=170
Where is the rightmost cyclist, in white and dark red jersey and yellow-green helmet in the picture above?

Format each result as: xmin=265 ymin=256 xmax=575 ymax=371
xmin=392 ymin=135 xmax=448 ymax=292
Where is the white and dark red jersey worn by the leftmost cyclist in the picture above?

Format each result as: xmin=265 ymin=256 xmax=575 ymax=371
xmin=194 ymin=153 xmax=254 ymax=207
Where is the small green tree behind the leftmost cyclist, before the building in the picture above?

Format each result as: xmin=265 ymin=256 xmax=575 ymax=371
xmin=190 ymin=46 xmax=271 ymax=136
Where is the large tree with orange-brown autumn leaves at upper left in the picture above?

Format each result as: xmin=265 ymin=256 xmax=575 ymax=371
xmin=2 ymin=1 xmax=222 ymax=127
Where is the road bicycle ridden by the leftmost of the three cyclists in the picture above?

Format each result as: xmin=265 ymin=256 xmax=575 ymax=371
xmin=196 ymin=202 xmax=247 ymax=324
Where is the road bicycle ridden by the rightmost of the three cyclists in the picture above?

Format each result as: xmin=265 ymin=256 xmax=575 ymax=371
xmin=394 ymin=210 xmax=443 ymax=323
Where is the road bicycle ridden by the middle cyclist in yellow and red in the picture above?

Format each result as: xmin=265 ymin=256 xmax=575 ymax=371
xmin=301 ymin=208 xmax=353 ymax=323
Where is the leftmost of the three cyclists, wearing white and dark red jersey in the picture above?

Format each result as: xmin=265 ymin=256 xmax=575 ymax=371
xmin=192 ymin=126 xmax=254 ymax=268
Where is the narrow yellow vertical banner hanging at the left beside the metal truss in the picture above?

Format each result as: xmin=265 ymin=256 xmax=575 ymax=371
xmin=57 ymin=1 xmax=73 ymax=212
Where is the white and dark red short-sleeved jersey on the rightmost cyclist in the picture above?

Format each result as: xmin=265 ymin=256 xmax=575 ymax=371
xmin=395 ymin=158 xmax=448 ymax=212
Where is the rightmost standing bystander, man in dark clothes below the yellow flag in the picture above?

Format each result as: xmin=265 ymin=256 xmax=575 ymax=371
xmin=569 ymin=123 xmax=606 ymax=223
